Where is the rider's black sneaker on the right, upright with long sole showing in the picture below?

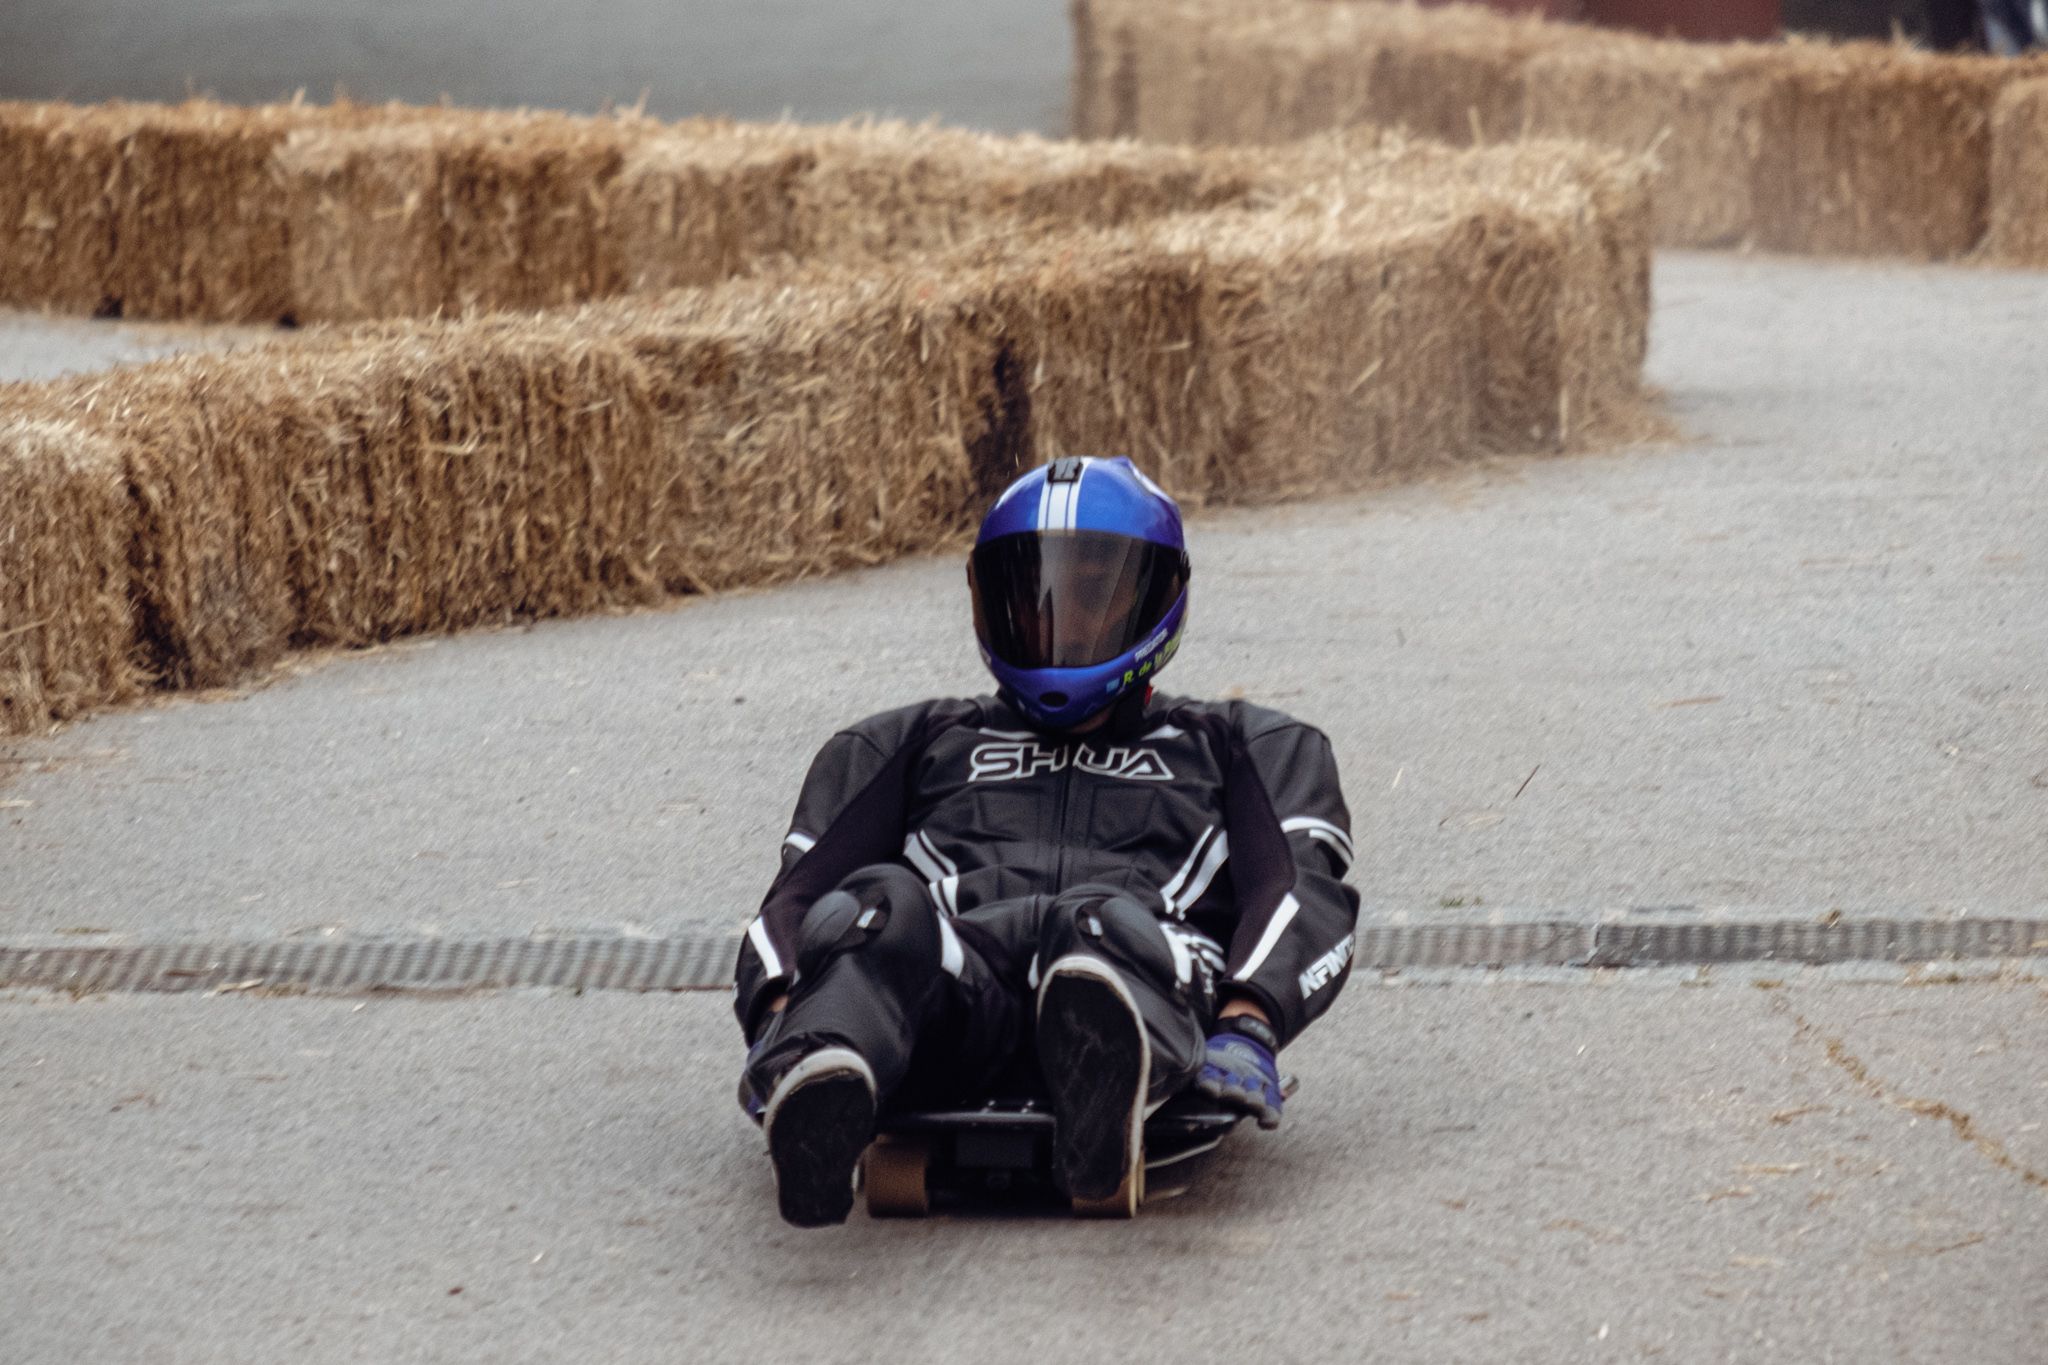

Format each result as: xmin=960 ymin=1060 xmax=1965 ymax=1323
xmin=1038 ymin=954 xmax=1151 ymax=1199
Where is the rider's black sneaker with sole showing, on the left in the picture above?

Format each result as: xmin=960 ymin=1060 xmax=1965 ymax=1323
xmin=762 ymin=1048 xmax=874 ymax=1228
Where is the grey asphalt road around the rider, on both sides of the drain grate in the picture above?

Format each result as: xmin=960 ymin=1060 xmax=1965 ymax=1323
xmin=0 ymin=256 xmax=2048 ymax=1365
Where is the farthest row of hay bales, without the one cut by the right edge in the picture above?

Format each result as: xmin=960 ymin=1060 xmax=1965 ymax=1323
xmin=1075 ymin=0 xmax=2044 ymax=258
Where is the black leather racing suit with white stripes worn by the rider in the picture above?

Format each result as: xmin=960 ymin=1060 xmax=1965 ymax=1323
xmin=735 ymin=698 xmax=1358 ymax=1101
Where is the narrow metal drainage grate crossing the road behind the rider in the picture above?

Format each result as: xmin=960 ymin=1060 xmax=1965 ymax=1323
xmin=0 ymin=919 xmax=2048 ymax=995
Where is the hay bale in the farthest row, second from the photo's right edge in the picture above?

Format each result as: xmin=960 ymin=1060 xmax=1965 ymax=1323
xmin=1755 ymin=43 xmax=2011 ymax=258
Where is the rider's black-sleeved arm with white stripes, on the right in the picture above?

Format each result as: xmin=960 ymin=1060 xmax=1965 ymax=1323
xmin=1219 ymin=708 xmax=1358 ymax=1044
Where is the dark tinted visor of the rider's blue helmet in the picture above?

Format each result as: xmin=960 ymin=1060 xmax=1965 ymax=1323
xmin=973 ymin=530 xmax=1188 ymax=669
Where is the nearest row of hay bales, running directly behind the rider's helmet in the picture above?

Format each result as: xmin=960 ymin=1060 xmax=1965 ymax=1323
xmin=0 ymin=139 xmax=1645 ymax=729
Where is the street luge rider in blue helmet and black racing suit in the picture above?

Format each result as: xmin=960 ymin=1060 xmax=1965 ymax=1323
xmin=735 ymin=458 xmax=1358 ymax=1226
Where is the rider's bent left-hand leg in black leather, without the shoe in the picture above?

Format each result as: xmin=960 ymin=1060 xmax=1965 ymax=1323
xmin=748 ymin=864 xmax=965 ymax=1097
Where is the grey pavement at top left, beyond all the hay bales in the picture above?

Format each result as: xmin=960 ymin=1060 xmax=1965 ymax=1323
xmin=0 ymin=0 xmax=1069 ymax=133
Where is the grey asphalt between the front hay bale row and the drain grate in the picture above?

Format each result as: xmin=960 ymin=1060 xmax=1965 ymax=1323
xmin=0 ymin=256 xmax=2048 ymax=941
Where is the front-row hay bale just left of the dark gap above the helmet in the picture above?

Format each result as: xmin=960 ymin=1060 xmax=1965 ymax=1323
xmin=575 ymin=270 xmax=997 ymax=591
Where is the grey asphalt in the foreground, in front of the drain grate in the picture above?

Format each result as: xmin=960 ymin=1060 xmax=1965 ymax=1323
xmin=0 ymin=974 xmax=2048 ymax=1365
